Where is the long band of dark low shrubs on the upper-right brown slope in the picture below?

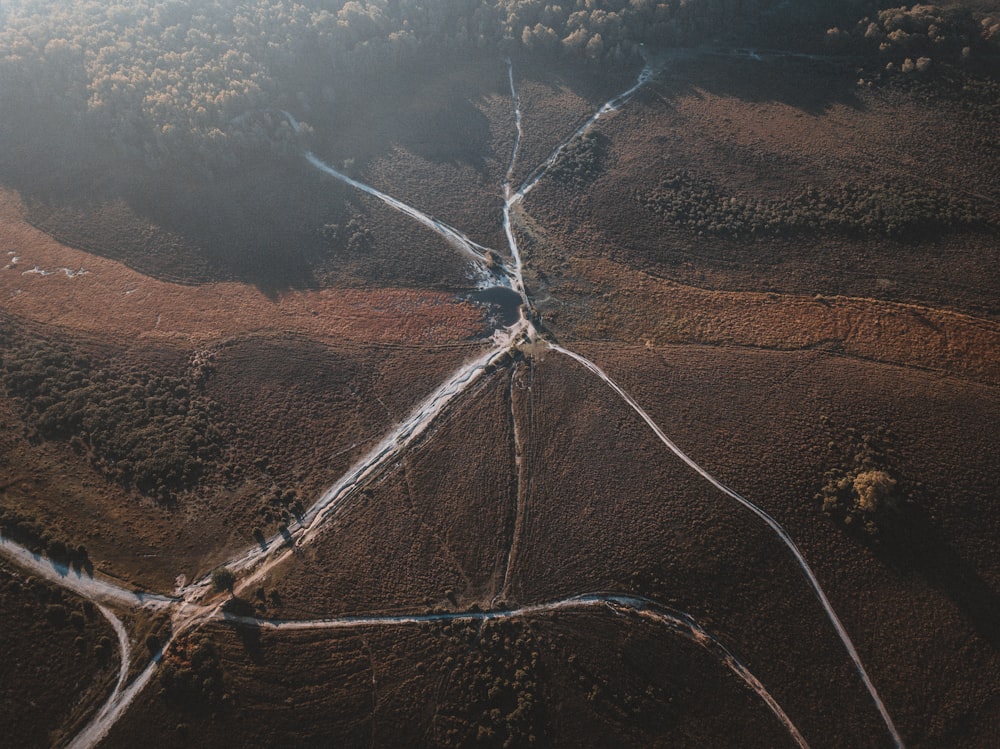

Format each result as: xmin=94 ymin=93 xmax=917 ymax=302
xmin=636 ymin=171 xmax=987 ymax=238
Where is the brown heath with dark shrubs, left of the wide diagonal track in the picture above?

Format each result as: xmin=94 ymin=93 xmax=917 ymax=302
xmin=0 ymin=316 xmax=478 ymax=590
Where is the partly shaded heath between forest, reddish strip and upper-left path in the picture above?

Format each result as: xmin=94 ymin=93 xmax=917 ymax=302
xmin=18 ymin=139 xmax=484 ymax=296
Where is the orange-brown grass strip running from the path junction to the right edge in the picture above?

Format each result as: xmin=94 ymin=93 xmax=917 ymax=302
xmin=543 ymin=260 xmax=1000 ymax=384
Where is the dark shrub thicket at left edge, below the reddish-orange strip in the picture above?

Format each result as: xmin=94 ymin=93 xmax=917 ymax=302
xmin=0 ymin=340 xmax=222 ymax=500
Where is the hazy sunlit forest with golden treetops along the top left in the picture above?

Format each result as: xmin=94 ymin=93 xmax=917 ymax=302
xmin=0 ymin=0 xmax=867 ymax=168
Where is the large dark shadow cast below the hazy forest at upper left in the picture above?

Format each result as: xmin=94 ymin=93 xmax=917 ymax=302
xmin=2 ymin=143 xmax=347 ymax=298
